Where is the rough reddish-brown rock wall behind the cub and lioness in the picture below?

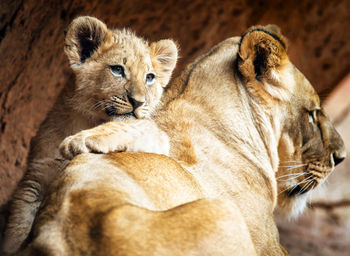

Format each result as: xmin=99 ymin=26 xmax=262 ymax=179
xmin=0 ymin=0 xmax=350 ymax=255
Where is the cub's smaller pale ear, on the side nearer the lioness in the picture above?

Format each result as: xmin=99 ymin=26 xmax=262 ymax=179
xmin=150 ymin=39 xmax=178 ymax=87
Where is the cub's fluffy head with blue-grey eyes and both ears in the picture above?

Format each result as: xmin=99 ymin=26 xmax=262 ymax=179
xmin=64 ymin=16 xmax=177 ymax=120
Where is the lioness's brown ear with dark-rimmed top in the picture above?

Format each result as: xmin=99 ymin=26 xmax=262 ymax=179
xmin=237 ymin=25 xmax=288 ymax=81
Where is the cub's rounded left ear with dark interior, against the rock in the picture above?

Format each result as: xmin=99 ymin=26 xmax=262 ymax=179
xmin=64 ymin=16 xmax=111 ymax=67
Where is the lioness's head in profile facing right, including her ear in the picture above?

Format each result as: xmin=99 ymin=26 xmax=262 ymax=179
xmin=237 ymin=25 xmax=346 ymax=216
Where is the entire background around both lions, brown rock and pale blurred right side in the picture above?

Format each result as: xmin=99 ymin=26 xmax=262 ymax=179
xmin=0 ymin=0 xmax=350 ymax=256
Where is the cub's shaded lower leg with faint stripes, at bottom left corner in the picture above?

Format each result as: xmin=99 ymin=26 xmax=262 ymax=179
xmin=2 ymin=158 xmax=68 ymax=254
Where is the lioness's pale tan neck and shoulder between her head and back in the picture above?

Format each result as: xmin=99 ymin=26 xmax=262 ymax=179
xmin=154 ymin=38 xmax=279 ymax=255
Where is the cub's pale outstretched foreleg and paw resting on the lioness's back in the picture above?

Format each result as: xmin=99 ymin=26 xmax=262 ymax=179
xmin=60 ymin=120 xmax=170 ymax=159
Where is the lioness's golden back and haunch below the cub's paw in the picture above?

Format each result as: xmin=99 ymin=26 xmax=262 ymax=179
xmin=27 ymin=153 xmax=255 ymax=255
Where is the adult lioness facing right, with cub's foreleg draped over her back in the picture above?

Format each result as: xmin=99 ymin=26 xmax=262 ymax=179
xmin=24 ymin=25 xmax=345 ymax=256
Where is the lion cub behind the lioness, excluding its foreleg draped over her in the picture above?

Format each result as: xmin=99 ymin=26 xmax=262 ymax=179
xmin=3 ymin=17 xmax=177 ymax=254
